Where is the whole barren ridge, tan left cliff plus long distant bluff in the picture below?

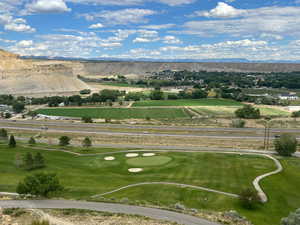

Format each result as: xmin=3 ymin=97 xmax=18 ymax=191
xmin=0 ymin=49 xmax=300 ymax=95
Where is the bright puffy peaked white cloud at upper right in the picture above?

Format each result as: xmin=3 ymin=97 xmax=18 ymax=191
xmin=195 ymin=2 xmax=247 ymax=18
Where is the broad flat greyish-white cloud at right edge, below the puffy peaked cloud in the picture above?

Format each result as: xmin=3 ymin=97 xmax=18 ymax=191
xmin=183 ymin=6 xmax=300 ymax=37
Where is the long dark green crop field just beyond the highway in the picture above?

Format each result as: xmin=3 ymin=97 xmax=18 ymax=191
xmin=37 ymin=107 xmax=189 ymax=120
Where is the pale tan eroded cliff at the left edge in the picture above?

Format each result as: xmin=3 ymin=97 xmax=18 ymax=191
xmin=0 ymin=50 xmax=89 ymax=95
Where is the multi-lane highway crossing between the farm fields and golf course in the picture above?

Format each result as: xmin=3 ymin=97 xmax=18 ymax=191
xmin=0 ymin=120 xmax=300 ymax=140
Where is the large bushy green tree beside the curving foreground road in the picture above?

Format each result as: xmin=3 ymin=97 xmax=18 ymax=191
xmin=17 ymin=173 xmax=64 ymax=197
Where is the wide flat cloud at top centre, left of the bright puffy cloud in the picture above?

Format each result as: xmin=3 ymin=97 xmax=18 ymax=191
xmin=81 ymin=8 xmax=155 ymax=24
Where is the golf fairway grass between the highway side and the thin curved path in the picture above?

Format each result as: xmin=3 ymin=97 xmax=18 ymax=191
xmin=0 ymin=146 xmax=275 ymax=198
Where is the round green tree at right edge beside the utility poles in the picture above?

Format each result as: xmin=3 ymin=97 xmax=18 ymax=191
xmin=274 ymin=134 xmax=298 ymax=156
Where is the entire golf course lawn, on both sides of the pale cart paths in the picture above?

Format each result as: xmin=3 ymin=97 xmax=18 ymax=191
xmin=0 ymin=145 xmax=300 ymax=225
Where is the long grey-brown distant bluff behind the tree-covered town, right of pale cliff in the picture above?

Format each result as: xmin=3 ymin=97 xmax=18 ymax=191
xmin=81 ymin=62 xmax=300 ymax=75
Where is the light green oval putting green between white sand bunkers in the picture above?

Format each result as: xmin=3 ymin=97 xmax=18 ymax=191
xmin=126 ymin=156 xmax=172 ymax=167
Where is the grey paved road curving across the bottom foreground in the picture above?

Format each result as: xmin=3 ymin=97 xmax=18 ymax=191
xmin=0 ymin=200 xmax=220 ymax=225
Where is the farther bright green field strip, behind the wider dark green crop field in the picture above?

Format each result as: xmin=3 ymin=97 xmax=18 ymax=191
xmin=132 ymin=98 xmax=243 ymax=107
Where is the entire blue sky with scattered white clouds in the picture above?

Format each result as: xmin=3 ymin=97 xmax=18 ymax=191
xmin=0 ymin=0 xmax=300 ymax=60
